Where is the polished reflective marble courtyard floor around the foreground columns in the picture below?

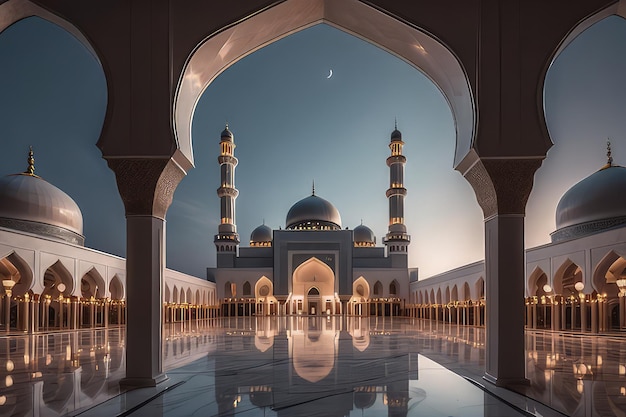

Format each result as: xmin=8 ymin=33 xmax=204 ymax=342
xmin=0 ymin=317 xmax=626 ymax=417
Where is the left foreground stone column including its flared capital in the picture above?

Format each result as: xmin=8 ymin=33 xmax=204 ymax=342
xmin=107 ymin=158 xmax=185 ymax=387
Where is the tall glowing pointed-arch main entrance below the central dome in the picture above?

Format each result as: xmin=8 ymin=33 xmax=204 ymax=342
xmin=286 ymin=256 xmax=340 ymax=315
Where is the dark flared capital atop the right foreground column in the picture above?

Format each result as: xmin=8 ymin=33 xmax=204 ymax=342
xmin=463 ymin=157 xmax=543 ymax=219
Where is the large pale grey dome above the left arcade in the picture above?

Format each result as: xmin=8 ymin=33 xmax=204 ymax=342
xmin=0 ymin=173 xmax=84 ymax=245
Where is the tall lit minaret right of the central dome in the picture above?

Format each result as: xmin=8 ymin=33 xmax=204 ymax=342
xmin=383 ymin=123 xmax=411 ymax=266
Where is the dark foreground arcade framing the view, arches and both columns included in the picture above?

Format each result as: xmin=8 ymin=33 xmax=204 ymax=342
xmin=0 ymin=0 xmax=624 ymax=385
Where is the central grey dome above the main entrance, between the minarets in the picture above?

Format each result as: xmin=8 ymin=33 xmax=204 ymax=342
xmin=285 ymin=194 xmax=341 ymax=230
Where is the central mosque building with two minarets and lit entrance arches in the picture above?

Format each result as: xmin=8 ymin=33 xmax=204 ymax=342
xmin=207 ymin=126 xmax=417 ymax=316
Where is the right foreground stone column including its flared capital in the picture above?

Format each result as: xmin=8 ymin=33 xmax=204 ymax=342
xmin=457 ymin=155 xmax=541 ymax=386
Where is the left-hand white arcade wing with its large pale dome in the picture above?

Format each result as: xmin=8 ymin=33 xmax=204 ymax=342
xmin=0 ymin=149 xmax=217 ymax=333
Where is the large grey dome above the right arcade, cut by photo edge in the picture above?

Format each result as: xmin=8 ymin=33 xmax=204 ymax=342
xmin=552 ymin=165 xmax=626 ymax=241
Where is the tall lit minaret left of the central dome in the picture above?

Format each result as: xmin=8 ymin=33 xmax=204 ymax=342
xmin=214 ymin=124 xmax=239 ymax=267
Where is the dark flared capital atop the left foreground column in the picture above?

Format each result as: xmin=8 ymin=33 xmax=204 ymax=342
xmin=107 ymin=158 xmax=187 ymax=219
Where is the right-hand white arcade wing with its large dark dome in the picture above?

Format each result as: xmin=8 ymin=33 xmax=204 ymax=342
xmin=409 ymin=144 xmax=626 ymax=333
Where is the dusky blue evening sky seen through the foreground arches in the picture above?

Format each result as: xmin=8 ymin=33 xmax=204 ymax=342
xmin=0 ymin=17 xmax=626 ymax=278
